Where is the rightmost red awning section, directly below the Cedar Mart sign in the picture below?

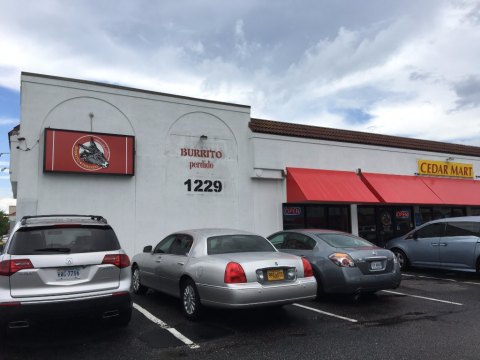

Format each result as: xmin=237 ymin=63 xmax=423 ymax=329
xmin=421 ymin=177 xmax=480 ymax=205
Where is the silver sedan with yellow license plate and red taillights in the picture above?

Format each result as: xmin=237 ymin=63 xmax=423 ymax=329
xmin=132 ymin=229 xmax=317 ymax=319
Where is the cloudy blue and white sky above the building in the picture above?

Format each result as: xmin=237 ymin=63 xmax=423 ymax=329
xmin=0 ymin=0 xmax=480 ymax=210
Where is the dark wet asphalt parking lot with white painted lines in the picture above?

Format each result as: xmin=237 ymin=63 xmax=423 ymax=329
xmin=0 ymin=270 xmax=480 ymax=360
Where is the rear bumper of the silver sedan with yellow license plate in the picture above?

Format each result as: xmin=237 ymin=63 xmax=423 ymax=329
xmin=197 ymin=277 xmax=317 ymax=308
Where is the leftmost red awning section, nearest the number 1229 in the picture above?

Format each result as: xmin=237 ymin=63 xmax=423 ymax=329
xmin=287 ymin=168 xmax=379 ymax=203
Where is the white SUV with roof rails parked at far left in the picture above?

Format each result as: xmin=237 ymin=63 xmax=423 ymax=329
xmin=0 ymin=215 xmax=132 ymax=334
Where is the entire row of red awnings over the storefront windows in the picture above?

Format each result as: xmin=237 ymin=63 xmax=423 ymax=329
xmin=287 ymin=168 xmax=480 ymax=206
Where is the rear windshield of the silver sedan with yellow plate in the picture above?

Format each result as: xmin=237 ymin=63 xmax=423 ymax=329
xmin=207 ymin=235 xmax=276 ymax=255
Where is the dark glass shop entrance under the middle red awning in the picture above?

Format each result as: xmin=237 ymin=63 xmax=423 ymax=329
xmin=358 ymin=206 xmax=414 ymax=246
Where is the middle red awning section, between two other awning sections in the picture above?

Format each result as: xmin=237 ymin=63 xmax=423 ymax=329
xmin=361 ymin=173 xmax=443 ymax=205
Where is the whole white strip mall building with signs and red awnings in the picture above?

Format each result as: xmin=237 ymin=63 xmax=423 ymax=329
xmin=9 ymin=73 xmax=480 ymax=254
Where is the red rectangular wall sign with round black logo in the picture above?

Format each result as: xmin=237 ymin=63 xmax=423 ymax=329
xmin=43 ymin=128 xmax=135 ymax=176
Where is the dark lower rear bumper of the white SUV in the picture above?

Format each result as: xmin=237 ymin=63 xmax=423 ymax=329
xmin=0 ymin=291 xmax=132 ymax=328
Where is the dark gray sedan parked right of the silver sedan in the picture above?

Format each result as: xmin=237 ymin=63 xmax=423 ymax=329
xmin=268 ymin=229 xmax=401 ymax=296
